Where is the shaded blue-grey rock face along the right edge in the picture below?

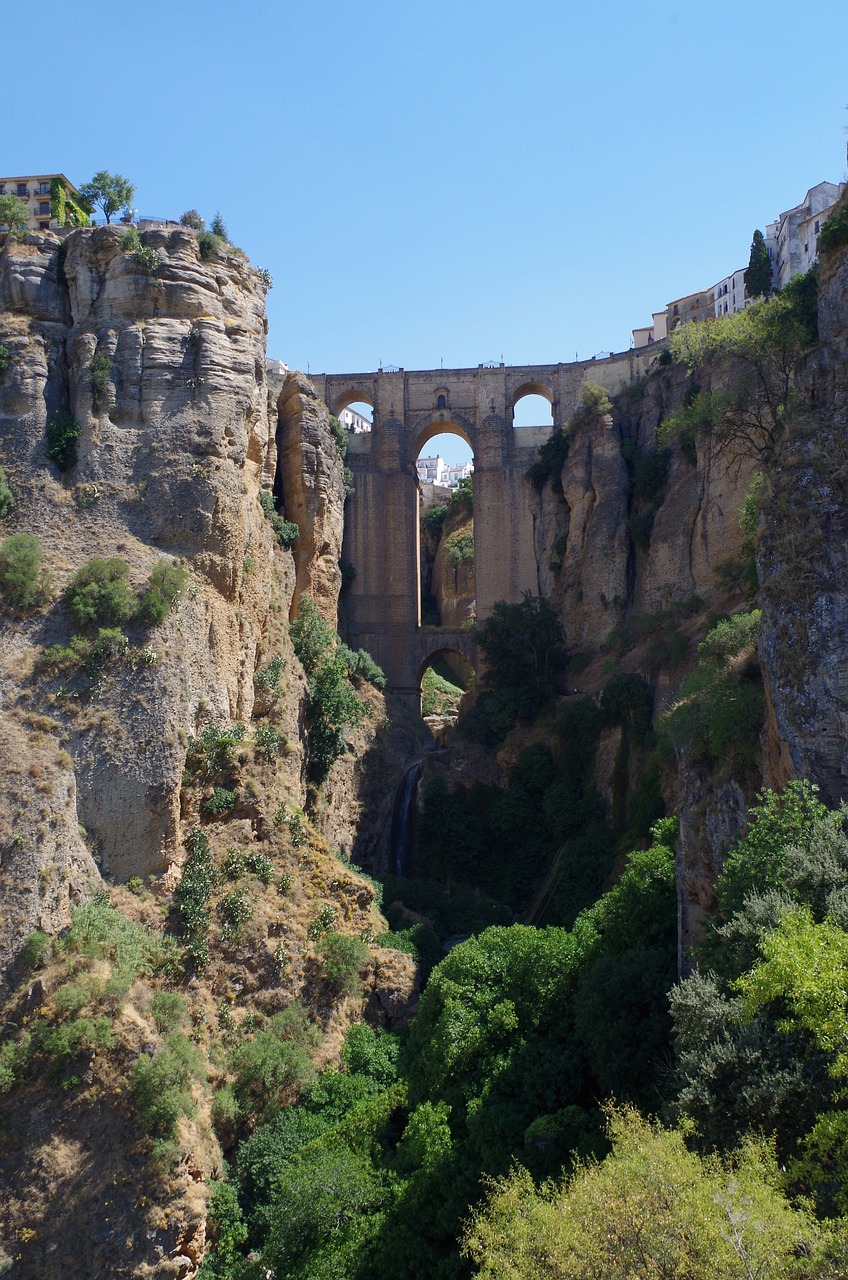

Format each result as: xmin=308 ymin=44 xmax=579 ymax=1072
xmin=760 ymin=239 xmax=848 ymax=804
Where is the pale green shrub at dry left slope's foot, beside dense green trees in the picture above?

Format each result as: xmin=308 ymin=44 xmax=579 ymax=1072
xmin=229 ymin=1005 xmax=320 ymax=1124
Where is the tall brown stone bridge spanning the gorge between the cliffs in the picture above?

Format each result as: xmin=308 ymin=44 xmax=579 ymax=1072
xmin=311 ymin=348 xmax=656 ymax=709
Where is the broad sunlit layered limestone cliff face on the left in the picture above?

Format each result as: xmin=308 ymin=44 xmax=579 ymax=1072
xmin=0 ymin=227 xmax=289 ymax=967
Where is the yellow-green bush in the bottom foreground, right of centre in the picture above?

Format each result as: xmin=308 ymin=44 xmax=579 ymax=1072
xmin=464 ymin=1110 xmax=819 ymax=1280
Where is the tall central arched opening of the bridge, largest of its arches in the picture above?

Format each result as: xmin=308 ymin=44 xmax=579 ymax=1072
xmin=415 ymin=421 xmax=477 ymax=627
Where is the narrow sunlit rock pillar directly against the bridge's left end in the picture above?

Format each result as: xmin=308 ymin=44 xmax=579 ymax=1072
xmin=277 ymin=372 xmax=345 ymax=626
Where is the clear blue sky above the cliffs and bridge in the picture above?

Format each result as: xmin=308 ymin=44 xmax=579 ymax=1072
xmin=8 ymin=0 xmax=848 ymax=463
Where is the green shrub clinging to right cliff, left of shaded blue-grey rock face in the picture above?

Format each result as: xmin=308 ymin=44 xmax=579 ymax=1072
xmin=662 ymin=609 xmax=763 ymax=760
